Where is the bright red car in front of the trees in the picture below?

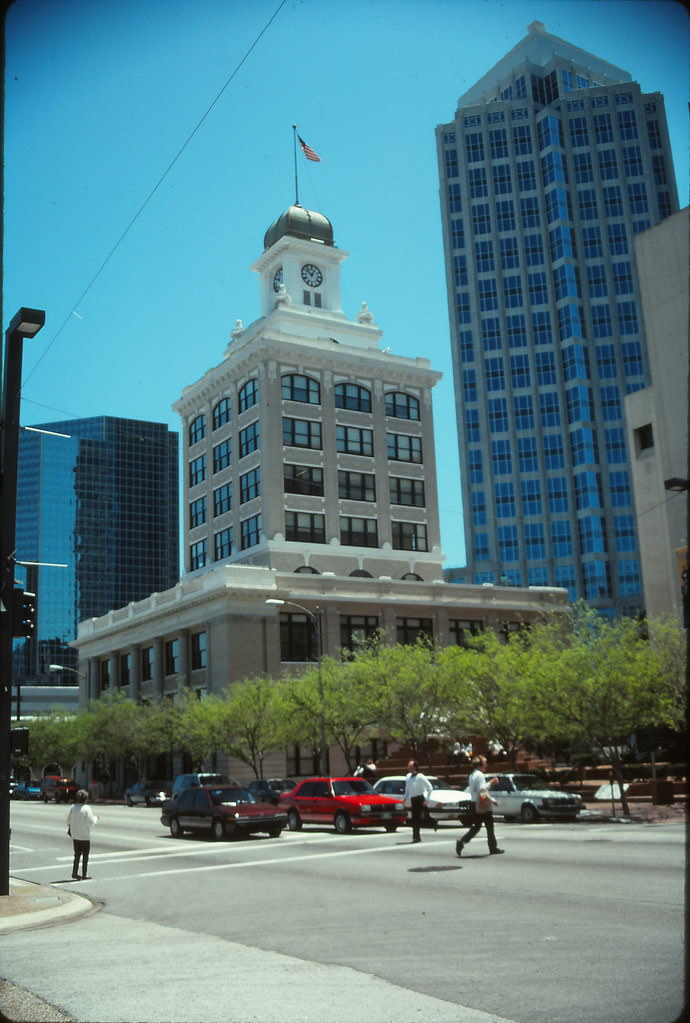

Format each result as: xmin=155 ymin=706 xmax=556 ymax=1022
xmin=278 ymin=777 xmax=405 ymax=835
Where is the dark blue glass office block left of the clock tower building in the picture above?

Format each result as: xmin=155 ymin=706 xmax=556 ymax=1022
xmin=14 ymin=416 xmax=179 ymax=683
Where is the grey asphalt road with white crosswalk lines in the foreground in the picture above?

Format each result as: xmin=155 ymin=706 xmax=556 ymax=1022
xmin=0 ymin=803 xmax=685 ymax=1023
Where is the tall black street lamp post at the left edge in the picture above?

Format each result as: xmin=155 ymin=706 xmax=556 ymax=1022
xmin=0 ymin=308 xmax=45 ymax=895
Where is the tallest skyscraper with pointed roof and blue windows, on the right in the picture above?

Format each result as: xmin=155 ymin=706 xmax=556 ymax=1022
xmin=436 ymin=21 xmax=678 ymax=614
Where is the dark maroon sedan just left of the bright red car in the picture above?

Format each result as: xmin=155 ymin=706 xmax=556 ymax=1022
xmin=161 ymin=785 xmax=288 ymax=839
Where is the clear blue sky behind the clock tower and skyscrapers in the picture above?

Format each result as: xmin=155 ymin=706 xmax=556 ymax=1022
xmin=3 ymin=0 xmax=690 ymax=566
